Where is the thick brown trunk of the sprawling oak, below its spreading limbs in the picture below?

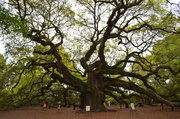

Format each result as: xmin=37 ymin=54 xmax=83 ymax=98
xmin=81 ymin=73 xmax=106 ymax=111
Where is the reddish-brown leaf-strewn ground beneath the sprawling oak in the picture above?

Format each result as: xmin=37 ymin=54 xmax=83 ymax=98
xmin=0 ymin=105 xmax=180 ymax=119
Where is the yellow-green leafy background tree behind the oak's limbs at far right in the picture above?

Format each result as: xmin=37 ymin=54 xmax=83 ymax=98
xmin=150 ymin=34 xmax=180 ymax=100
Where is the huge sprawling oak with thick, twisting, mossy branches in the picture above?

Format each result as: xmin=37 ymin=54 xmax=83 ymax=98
xmin=1 ymin=0 xmax=180 ymax=111
